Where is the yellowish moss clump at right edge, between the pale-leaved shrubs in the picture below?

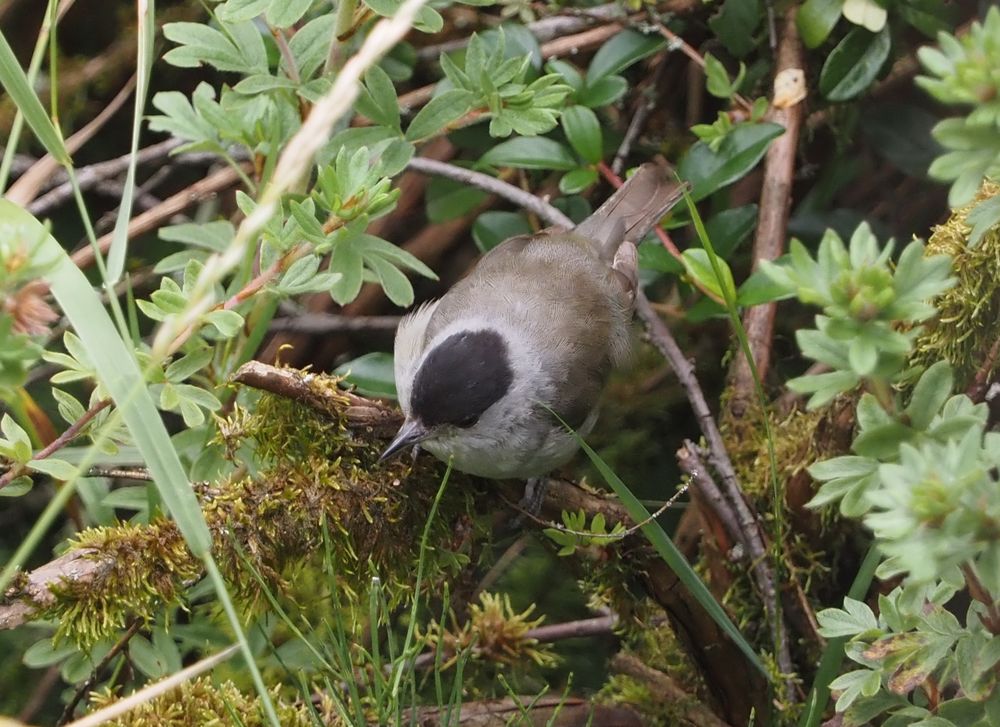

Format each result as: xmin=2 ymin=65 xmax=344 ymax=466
xmin=912 ymin=181 xmax=1000 ymax=389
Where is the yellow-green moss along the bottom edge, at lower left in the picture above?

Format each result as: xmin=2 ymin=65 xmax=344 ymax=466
xmin=92 ymin=677 xmax=334 ymax=727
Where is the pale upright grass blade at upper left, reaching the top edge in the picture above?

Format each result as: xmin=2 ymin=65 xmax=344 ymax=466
xmin=107 ymin=0 xmax=156 ymax=285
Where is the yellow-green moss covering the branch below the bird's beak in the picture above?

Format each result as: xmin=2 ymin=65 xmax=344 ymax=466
xmin=27 ymin=377 xmax=483 ymax=648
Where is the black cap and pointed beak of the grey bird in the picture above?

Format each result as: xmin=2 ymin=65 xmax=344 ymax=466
xmin=380 ymin=329 xmax=514 ymax=460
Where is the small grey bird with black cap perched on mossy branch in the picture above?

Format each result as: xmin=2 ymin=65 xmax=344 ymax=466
xmin=382 ymin=163 xmax=682 ymax=490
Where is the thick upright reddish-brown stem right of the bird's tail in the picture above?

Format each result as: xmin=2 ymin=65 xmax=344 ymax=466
xmin=729 ymin=6 xmax=804 ymax=417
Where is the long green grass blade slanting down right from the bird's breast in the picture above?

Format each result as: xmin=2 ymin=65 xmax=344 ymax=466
xmin=568 ymin=426 xmax=770 ymax=679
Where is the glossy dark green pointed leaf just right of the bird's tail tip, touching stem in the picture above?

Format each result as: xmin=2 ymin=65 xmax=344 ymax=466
xmin=677 ymin=123 xmax=785 ymax=201
